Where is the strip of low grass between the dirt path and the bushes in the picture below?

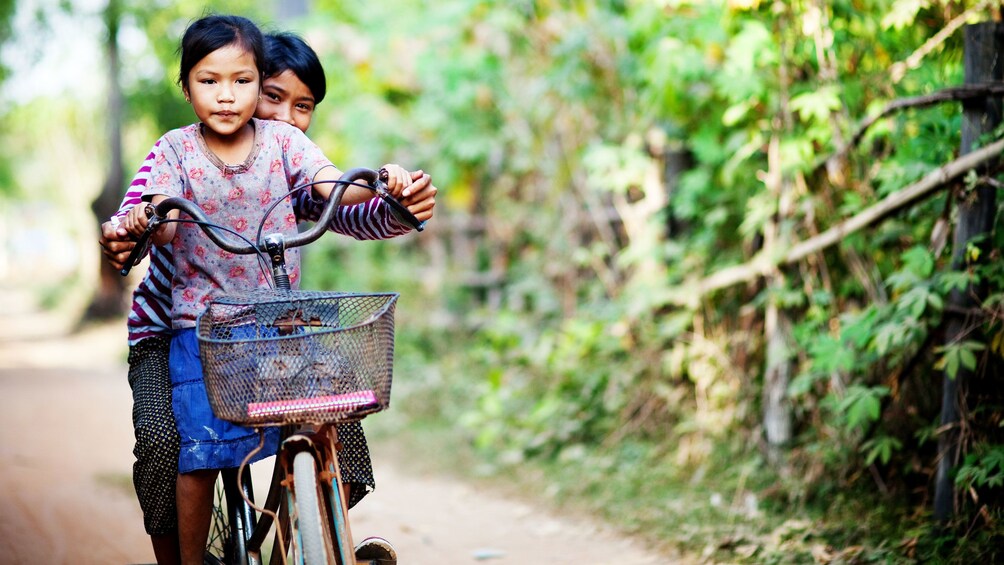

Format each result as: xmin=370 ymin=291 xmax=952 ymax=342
xmin=367 ymin=401 xmax=1004 ymax=565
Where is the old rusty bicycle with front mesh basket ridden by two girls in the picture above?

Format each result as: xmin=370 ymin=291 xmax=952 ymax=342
xmin=121 ymin=169 xmax=425 ymax=565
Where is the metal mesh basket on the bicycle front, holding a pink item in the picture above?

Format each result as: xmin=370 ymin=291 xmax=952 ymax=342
xmin=198 ymin=291 xmax=398 ymax=426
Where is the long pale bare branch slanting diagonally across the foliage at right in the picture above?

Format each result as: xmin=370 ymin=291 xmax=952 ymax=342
xmin=672 ymin=139 xmax=1004 ymax=305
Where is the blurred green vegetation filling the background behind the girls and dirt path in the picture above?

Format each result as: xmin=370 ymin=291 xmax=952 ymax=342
xmin=0 ymin=0 xmax=1004 ymax=563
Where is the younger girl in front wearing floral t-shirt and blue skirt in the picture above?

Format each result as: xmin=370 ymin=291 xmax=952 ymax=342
xmin=123 ymin=16 xmax=411 ymax=563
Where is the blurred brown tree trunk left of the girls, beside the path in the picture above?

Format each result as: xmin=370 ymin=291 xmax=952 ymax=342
xmin=86 ymin=0 xmax=126 ymax=319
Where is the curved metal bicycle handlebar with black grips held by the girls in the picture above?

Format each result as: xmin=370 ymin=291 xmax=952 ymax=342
xmin=119 ymin=167 xmax=426 ymax=277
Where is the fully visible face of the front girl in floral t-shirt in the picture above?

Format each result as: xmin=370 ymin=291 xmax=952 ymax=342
xmin=185 ymin=45 xmax=260 ymax=137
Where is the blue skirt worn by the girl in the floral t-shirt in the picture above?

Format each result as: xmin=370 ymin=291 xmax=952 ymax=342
xmin=169 ymin=328 xmax=279 ymax=473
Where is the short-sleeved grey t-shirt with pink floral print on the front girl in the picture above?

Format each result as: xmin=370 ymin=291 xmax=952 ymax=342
xmin=144 ymin=118 xmax=331 ymax=329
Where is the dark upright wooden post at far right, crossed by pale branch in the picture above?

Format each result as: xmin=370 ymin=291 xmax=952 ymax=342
xmin=934 ymin=22 xmax=1004 ymax=523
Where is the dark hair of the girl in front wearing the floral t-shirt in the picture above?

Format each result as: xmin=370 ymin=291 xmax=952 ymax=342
xmin=178 ymin=15 xmax=266 ymax=90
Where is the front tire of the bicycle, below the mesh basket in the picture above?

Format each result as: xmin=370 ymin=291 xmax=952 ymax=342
xmin=293 ymin=452 xmax=340 ymax=565
